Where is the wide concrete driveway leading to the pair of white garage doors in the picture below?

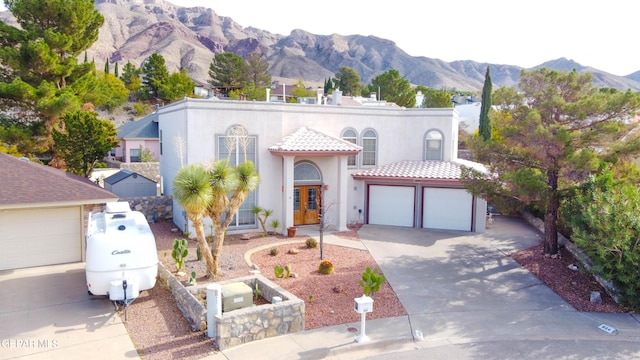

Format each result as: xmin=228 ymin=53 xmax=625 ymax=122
xmin=358 ymin=216 xmax=640 ymax=358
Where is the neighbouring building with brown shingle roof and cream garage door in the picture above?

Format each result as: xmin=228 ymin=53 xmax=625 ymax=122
xmin=0 ymin=153 xmax=118 ymax=270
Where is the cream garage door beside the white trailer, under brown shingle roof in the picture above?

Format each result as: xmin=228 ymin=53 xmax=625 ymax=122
xmin=0 ymin=207 xmax=82 ymax=270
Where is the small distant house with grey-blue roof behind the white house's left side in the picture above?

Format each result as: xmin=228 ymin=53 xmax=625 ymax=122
xmin=112 ymin=112 xmax=160 ymax=163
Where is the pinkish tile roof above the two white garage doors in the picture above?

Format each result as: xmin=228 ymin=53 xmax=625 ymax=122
xmin=352 ymin=159 xmax=481 ymax=181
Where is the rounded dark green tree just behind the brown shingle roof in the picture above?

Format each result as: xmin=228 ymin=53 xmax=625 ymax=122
xmin=52 ymin=111 xmax=118 ymax=178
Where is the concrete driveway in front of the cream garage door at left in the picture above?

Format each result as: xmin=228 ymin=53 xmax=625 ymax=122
xmin=0 ymin=263 xmax=138 ymax=359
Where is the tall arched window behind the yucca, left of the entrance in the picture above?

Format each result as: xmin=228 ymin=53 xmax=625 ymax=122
xmin=216 ymin=125 xmax=258 ymax=228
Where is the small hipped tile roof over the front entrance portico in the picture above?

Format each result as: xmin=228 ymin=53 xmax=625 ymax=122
xmin=269 ymin=127 xmax=362 ymax=155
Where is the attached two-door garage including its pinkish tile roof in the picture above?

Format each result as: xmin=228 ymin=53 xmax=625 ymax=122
xmin=352 ymin=161 xmax=487 ymax=232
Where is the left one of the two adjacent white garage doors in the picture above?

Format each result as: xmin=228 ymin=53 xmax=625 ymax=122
xmin=369 ymin=185 xmax=415 ymax=227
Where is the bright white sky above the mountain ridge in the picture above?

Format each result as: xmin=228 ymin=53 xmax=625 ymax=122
xmin=0 ymin=0 xmax=640 ymax=76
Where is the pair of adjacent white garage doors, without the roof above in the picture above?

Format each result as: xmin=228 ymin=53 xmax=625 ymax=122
xmin=367 ymin=184 xmax=474 ymax=231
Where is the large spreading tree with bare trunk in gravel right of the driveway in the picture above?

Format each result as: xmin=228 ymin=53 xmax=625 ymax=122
xmin=462 ymin=68 xmax=640 ymax=255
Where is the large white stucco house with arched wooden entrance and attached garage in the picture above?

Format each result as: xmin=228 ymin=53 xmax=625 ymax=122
xmin=158 ymin=97 xmax=487 ymax=236
